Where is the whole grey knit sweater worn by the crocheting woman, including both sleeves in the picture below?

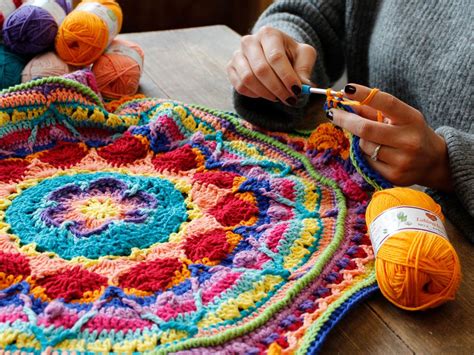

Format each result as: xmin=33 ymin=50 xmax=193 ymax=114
xmin=234 ymin=0 xmax=474 ymax=242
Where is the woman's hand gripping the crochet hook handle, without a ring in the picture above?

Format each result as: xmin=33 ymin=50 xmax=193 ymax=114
xmin=227 ymin=27 xmax=316 ymax=106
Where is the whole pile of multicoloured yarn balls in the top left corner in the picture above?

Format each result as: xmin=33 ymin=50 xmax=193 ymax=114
xmin=0 ymin=0 xmax=144 ymax=99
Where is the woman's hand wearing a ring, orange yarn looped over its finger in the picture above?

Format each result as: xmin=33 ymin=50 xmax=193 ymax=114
xmin=329 ymin=84 xmax=452 ymax=191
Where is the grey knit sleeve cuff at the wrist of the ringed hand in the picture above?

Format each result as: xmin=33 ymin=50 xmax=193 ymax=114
xmin=433 ymin=126 xmax=474 ymax=243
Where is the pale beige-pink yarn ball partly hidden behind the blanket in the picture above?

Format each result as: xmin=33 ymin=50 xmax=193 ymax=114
xmin=21 ymin=52 xmax=74 ymax=83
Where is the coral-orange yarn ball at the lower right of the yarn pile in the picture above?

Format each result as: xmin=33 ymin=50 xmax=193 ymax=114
xmin=92 ymin=39 xmax=144 ymax=99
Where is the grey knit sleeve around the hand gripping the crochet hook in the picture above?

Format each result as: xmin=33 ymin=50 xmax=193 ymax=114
xmin=234 ymin=0 xmax=345 ymax=130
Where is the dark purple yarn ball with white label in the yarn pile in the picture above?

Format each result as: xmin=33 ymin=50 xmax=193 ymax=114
xmin=3 ymin=0 xmax=72 ymax=54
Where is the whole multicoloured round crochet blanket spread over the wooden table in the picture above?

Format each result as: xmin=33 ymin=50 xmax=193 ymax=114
xmin=0 ymin=79 xmax=375 ymax=354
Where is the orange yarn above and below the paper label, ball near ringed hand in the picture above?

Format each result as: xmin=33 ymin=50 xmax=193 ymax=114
xmin=366 ymin=187 xmax=461 ymax=311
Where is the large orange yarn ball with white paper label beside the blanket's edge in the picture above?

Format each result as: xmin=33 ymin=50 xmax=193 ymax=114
xmin=366 ymin=187 xmax=461 ymax=311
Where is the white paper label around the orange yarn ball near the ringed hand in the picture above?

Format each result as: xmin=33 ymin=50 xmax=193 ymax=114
xmin=369 ymin=206 xmax=448 ymax=255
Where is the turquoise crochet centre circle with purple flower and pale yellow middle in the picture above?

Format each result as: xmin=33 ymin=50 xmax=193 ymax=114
xmin=6 ymin=173 xmax=187 ymax=259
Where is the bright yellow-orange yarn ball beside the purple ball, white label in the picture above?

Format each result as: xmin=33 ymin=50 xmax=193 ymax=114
xmin=56 ymin=0 xmax=123 ymax=66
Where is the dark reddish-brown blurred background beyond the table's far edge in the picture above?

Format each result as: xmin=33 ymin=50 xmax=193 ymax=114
xmin=74 ymin=0 xmax=273 ymax=35
